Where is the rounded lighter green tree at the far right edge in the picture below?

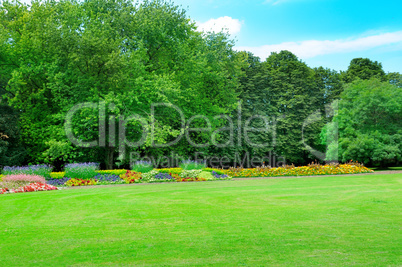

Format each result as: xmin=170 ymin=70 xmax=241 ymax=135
xmin=322 ymin=79 xmax=402 ymax=166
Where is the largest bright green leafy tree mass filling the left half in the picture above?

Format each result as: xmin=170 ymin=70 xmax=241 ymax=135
xmin=0 ymin=0 xmax=242 ymax=168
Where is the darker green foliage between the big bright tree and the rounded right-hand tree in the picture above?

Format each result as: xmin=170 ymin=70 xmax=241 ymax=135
xmin=232 ymin=51 xmax=343 ymax=166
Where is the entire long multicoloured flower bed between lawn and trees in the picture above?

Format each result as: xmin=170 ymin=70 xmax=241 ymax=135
xmin=0 ymin=162 xmax=373 ymax=193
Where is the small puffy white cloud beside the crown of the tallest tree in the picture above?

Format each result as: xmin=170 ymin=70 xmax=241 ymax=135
xmin=196 ymin=16 xmax=243 ymax=35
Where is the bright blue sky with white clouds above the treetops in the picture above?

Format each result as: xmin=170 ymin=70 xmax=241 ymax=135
xmin=173 ymin=0 xmax=402 ymax=73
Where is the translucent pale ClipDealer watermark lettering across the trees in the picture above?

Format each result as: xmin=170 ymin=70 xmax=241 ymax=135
xmin=65 ymin=102 xmax=340 ymax=167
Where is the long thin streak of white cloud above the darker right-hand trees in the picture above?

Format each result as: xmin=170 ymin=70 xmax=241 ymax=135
xmin=236 ymin=31 xmax=402 ymax=60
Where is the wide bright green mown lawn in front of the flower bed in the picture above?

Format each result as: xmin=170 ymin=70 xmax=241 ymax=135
xmin=0 ymin=174 xmax=402 ymax=266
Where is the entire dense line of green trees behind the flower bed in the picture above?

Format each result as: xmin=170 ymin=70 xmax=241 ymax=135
xmin=0 ymin=0 xmax=402 ymax=168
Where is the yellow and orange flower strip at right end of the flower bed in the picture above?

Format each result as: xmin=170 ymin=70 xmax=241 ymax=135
xmin=225 ymin=163 xmax=374 ymax=177
